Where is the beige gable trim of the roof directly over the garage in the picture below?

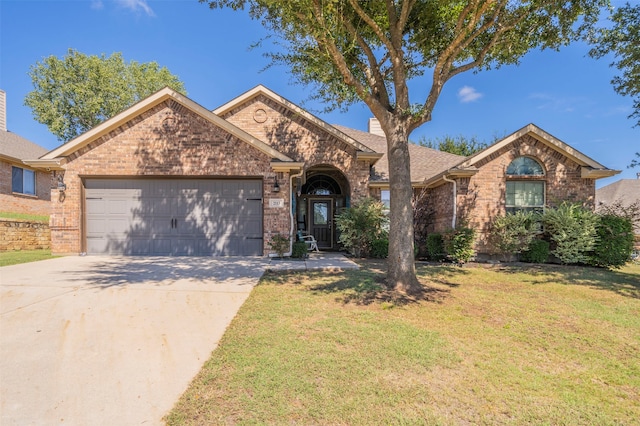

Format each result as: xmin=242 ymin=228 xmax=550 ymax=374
xmin=27 ymin=87 xmax=297 ymax=168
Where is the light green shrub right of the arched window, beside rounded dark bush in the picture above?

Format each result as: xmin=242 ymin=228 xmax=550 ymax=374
xmin=542 ymin=203 xmax=598 ymax=263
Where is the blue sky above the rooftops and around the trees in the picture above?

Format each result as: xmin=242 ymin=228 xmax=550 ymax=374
xmin=0 ymin=0 xmax=640 ymax=187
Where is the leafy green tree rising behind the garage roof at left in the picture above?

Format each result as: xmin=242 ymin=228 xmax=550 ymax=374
xmin=25 ymin=49 xmax=185 ymax=142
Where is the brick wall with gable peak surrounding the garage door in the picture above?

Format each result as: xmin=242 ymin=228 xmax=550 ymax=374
xmin=51 ymin=100 xmax=291 ymax=253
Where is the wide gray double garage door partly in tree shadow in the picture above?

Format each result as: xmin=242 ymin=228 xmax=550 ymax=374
xmin=85 ymin=179 xmax=262 ymax=256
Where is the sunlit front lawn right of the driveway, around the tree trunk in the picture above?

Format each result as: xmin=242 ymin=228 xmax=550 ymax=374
xmin=165 ymin=262 xmax=640 ymax=425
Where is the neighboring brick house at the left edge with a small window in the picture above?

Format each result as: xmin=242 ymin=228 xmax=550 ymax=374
xmin=0 ymin=90 xmax=51 ymax=215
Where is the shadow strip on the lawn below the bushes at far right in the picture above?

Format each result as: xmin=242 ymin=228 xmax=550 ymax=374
xmin=492 ymin=265 xmax=640 ymax=299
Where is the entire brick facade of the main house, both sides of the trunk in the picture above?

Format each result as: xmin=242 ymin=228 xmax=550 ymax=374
xmin=40 ymin=89 xmax=614 ymax=253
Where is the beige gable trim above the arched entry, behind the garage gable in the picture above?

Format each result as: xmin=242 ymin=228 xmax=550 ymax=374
xmin=213 ymin=84 xmax=382 ymax=162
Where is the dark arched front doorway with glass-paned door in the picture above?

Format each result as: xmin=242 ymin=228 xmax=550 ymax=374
xmin=296 ymin=166 xmax=350 ymax=250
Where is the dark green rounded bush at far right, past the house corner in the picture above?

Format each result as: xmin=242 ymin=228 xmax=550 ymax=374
xmin=589 ymin=214 xmax=634 ymax=268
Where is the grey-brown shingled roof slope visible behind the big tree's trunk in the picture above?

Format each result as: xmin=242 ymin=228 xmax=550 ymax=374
xmin=334 ymin=125 xmax=466 ymax=186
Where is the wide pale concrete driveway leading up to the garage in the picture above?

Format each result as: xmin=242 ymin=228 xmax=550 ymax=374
xmin=0 ymin=256 xmax=268 ymax=426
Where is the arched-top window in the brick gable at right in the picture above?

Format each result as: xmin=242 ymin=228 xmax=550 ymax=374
xmin=505 ymin=157 xmax=545 ymax=213
